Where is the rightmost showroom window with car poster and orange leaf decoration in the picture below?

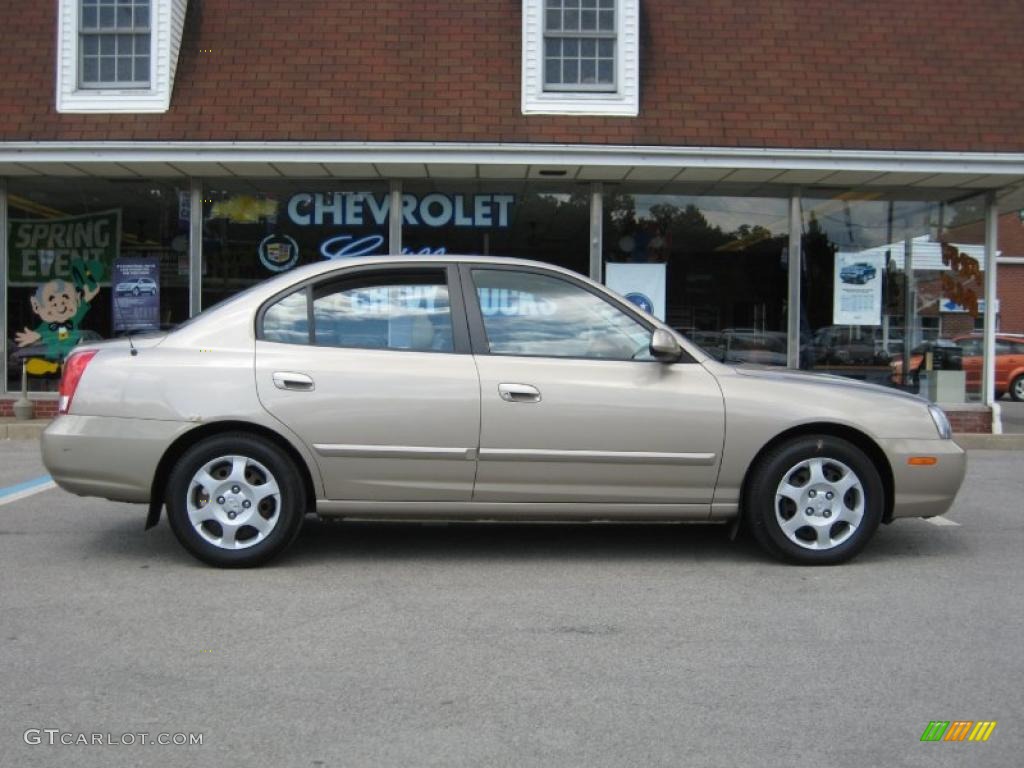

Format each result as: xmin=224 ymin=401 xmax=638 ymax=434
xmin=800 ymin=190 xmax=985 ymax=402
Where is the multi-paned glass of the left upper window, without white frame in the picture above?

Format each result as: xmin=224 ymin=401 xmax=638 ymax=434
xmin=79 ymin=0 xmax=152 ymax=88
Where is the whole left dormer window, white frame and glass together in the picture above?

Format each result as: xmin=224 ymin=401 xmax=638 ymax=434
xmin=56 ymin=0 xmax=188 ymax=113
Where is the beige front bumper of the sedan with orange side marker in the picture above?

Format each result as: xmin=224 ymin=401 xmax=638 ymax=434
xmin=880 ymin=439 xmax=967 ymax=518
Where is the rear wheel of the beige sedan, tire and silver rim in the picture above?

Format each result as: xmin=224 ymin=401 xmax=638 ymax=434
xmin=166 ymin=432 xmax=306 ymax=567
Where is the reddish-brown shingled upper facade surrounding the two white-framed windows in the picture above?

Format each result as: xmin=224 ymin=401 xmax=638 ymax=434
xmin=0 ymin=0 xmax=1024 ymax=152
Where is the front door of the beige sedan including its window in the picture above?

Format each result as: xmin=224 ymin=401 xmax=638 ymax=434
xmin=462 ymin=265 xmax=724 ymax=514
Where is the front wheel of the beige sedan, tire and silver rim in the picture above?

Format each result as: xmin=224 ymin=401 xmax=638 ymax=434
xmin=743 ymin=435 xmax=885 ymax=565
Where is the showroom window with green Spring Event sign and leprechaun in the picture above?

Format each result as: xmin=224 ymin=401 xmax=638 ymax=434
xmin=5 ymin=178 xmax=189 ymax=391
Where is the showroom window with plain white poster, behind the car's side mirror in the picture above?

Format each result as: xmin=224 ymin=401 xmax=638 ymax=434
xmin=601 ymin=185 xmax=788 ymax=366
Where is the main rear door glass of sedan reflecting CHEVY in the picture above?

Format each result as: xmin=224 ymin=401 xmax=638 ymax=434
xmin=313 ymin=272 xmax=454 ymax=352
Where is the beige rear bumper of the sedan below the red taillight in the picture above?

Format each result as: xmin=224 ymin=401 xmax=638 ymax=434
xmin=41 ymin=416 xmax=195 ymax=503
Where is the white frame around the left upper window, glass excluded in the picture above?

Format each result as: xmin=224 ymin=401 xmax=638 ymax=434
xmin=56 ymin=0 xmax=188 ymax=113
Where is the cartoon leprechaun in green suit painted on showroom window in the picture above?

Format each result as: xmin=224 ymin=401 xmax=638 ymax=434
xmin=14 ymin=259 xmax=103 ymax=376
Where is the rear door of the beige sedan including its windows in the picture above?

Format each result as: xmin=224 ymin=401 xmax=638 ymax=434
xmin=255 ymin=264 xmax=480 ymax=501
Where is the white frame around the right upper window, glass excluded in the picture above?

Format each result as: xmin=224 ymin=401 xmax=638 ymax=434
xmin=522 ymin=0 xmax=640 ymax=117
